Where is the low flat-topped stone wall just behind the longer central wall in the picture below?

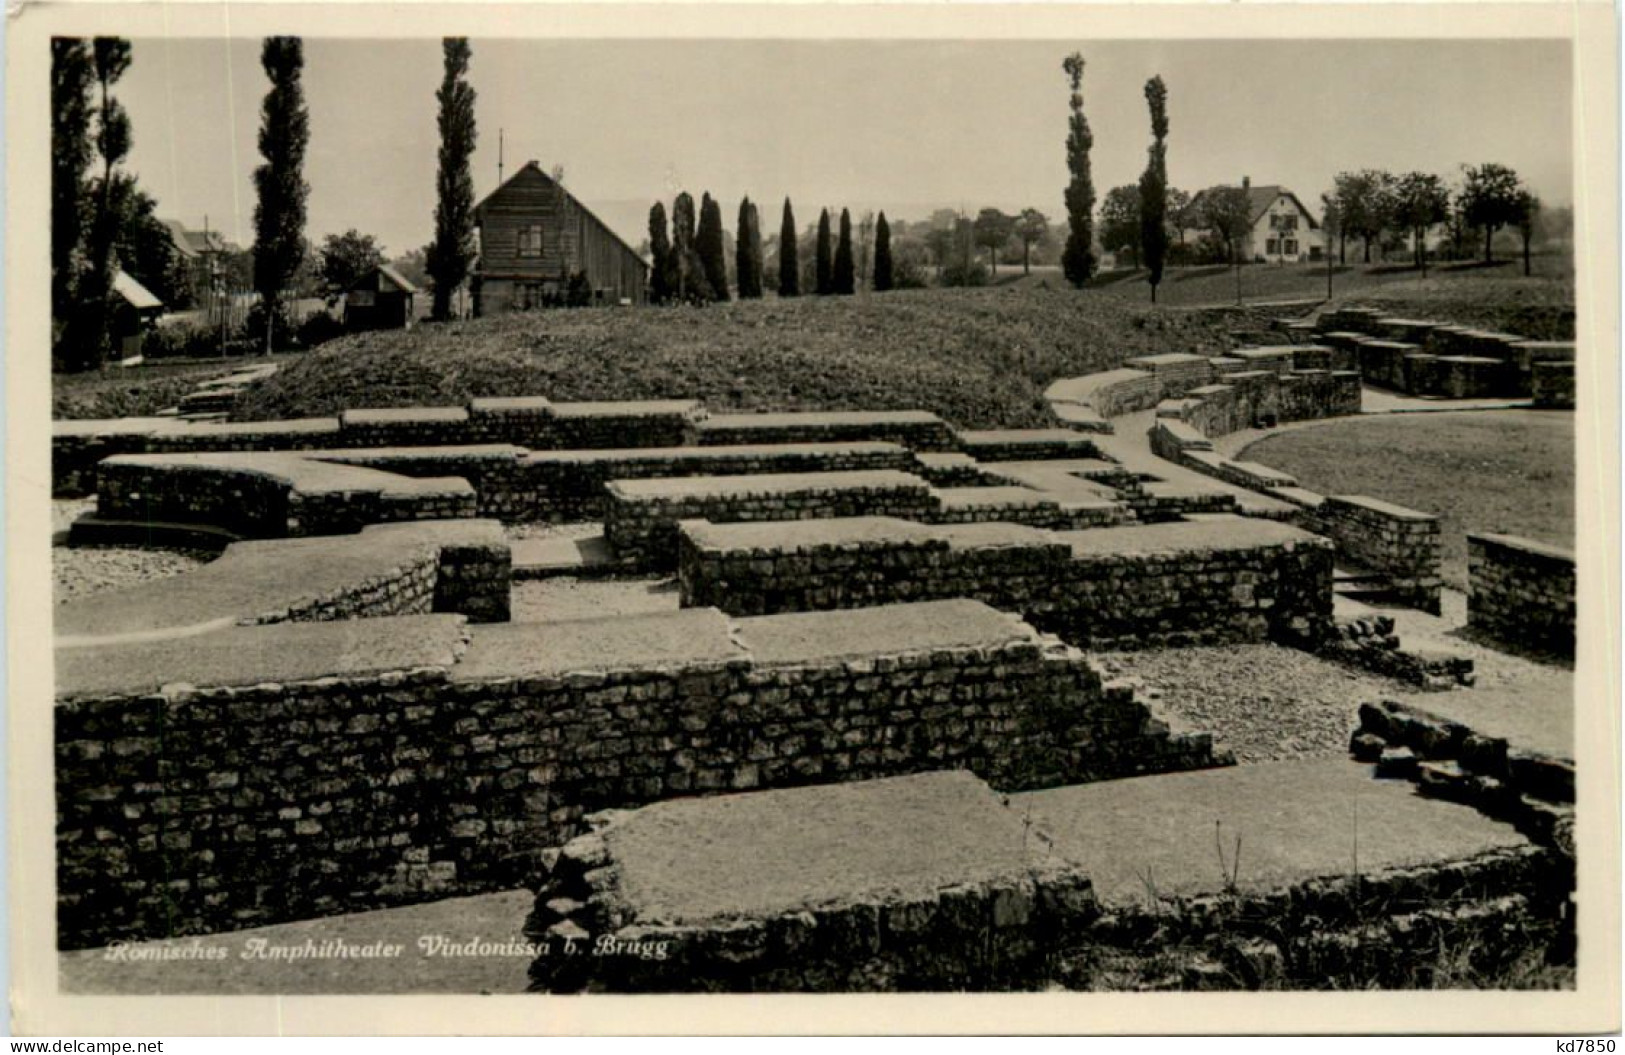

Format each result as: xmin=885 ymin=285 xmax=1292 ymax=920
xmin=605 ymin=470 xmax=938 ymax=569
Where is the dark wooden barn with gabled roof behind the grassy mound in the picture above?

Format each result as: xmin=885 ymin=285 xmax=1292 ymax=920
xmin=470 ymin=161 xmax=648 ymax=315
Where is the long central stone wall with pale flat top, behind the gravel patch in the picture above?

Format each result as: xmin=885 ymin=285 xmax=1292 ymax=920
xmin=678 ymin=517 xmax=1333 ymax=649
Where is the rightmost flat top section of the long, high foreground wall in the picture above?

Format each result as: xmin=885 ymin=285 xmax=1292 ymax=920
xmin=735 ymin=600 xmax=1035 ymax=665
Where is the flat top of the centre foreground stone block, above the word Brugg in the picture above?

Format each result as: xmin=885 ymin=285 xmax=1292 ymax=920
xmin=603 ymin=771 xmax=1038 ymax=923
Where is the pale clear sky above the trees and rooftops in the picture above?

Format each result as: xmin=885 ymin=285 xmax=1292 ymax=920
xmin=115 ymin=37 xmax=1573 ymax=255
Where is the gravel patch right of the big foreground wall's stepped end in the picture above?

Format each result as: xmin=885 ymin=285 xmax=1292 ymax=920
xmin=1095 ymin=645 xmax=1404 ymax=762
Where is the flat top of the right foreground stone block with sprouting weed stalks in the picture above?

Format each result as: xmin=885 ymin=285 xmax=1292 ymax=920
xmin=1009 ymin=759 xmax=1528 ymax=907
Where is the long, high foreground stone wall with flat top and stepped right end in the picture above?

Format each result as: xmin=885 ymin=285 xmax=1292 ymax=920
xmin=55 ymin=600 xmax=1224 ymax=948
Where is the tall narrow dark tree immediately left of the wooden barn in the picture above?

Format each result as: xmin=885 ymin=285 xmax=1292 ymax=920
xmin=424 ymin=37 xmax=476 ymax=322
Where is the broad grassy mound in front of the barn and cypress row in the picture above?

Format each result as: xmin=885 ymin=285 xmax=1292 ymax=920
xmin=236 ymin=288 xmax=1256 ymax=428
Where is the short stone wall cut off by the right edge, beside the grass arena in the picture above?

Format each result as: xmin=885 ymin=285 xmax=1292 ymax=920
xmin=1467 ymin=533 xmax=1575 ymax=655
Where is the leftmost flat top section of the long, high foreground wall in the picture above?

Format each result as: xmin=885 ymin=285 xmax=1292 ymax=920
xmin=55 ymin=614 xmax=463 ymax=701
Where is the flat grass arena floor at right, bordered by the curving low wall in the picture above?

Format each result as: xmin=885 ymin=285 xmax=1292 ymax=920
xmin=1240 ymin=410 xmax=1575 ymax=588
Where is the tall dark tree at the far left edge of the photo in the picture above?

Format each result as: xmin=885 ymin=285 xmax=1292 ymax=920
xmin=50 ymin=37 xmax=96 ymax=347
